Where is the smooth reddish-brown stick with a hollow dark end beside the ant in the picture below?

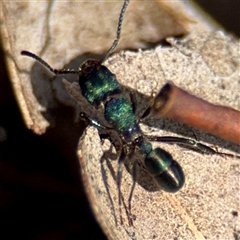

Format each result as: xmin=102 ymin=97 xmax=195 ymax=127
xmin=144 ymin=82 xmax=240 ymax=145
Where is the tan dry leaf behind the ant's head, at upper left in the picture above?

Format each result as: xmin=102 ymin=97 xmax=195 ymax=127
xmin=1 ymin=1 xmax=192 ymax=134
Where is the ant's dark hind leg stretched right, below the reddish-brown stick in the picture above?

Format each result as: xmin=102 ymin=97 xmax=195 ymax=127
xmin=146 ymin=135 xmax=240 ymax=158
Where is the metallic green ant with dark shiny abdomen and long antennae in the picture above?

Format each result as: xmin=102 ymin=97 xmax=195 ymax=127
xmin=21 ymin=0 xmax=238 ymax=225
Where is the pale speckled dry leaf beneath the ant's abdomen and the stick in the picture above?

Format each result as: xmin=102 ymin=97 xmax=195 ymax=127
xmin=76 ymin=32 xmax=240 ymax=240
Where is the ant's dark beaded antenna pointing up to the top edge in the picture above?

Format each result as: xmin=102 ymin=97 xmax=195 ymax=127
xmin=99 ymin=0 xmax=130 ymax=64
